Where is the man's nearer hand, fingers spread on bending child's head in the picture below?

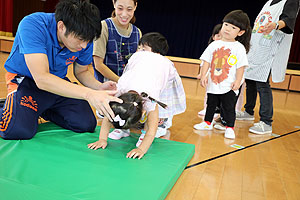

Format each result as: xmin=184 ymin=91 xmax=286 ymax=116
xmin=86 ymin=90 xmax=123 ymax=121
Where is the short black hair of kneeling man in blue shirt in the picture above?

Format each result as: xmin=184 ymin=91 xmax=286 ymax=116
xmin=55 ymin=0 xmax=102 ymax=42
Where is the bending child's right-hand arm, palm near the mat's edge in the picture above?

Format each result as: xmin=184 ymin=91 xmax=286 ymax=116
xmin=126 ymin=105 xmax=158 ymax=159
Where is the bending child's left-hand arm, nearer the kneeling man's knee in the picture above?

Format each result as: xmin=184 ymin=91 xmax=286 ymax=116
xmin=88 ymin=117 xmax=112 ymax=150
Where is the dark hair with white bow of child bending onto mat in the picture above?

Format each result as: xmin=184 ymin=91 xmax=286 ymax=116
xmin=109 ymin=91 xmax=143 ymax=129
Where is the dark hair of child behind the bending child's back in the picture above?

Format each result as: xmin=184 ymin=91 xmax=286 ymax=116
xmin=139 ymin=32 xmax=169 ymax=56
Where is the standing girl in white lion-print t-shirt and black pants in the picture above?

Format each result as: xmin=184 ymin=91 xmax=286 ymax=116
xmin=194 ymin=10 xmax=251 ymax=139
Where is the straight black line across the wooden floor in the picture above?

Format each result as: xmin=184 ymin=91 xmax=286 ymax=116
xmin=185 ymin=129 xmax=300 ymax=169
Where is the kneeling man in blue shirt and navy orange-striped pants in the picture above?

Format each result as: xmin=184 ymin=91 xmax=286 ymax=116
xmin=0 ymin=0 xmax=122 ymax=139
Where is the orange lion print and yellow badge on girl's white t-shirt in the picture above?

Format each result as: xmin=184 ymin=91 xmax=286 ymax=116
xmin=211 ymin=47 xmax=233 ymax=84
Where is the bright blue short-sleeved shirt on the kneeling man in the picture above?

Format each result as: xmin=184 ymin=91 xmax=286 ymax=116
xmin=4 ymin=13 xmax=93 ymax=78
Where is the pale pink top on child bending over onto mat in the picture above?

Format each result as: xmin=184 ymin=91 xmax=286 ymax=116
xmin=117 ymin=51 xmax=177 ymax=112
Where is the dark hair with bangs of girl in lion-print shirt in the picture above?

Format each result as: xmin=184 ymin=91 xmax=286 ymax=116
xmin=223 ymin=10 xmax=251 ymax=53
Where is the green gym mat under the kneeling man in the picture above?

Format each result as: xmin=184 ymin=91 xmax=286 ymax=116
xmin=0 ymin=123 xmax=195 ymax=200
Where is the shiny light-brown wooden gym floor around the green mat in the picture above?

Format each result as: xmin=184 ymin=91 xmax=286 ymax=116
xmin=0 ymin=53 xmax=300 ymax=200
